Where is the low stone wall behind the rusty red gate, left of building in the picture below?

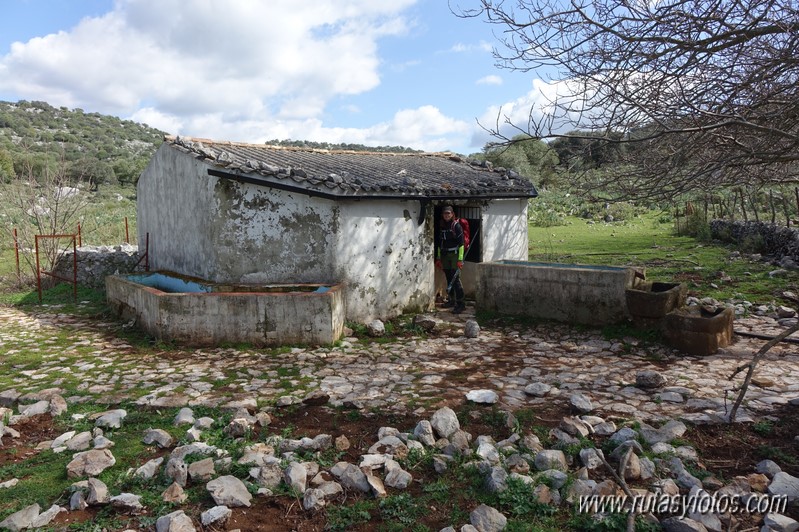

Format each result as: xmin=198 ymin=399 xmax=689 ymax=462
xmin=55 ymin=244 xmax=144 ymax=289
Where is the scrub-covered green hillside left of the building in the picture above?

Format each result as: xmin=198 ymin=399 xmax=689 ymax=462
xmin=0 ymin=101 xmax=165 ymax=186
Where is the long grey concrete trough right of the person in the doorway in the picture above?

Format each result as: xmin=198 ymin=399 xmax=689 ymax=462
xmin=476 ymin=260 xmax=636 ymax=325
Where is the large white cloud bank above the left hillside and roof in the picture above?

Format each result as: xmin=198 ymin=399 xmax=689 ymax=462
xmin=0 ymin=0 xmax=417 ymax=140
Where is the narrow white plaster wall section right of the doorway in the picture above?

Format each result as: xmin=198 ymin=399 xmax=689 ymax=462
xmin=480 ymin=198 xmax=529 ymax=262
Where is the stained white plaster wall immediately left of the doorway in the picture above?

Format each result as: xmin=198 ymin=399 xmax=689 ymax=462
xmin=335 ymin=201 xmax=435 ymax=322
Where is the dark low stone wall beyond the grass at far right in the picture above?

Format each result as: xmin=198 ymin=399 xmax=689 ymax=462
xmin=710 ymin=220 xmax=799 ymax=263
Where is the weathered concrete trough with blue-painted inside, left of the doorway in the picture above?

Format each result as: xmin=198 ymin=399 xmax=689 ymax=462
xmin=106 ymin=272 xmax=345 ymax=346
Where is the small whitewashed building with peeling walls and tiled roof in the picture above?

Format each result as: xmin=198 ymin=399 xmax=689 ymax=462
xmin=137 ymin=137 xmax=537 ymax=322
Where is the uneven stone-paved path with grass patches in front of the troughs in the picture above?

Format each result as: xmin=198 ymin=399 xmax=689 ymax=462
xmin=0 ymin=307 xmax=799 ymax=422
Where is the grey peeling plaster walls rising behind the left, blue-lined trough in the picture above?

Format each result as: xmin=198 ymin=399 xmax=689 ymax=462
xmin=137 ymin=146 xmax=338 ymax=284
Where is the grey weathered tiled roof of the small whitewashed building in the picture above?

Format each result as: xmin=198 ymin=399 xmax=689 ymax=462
xmin=170 ymin=136 xmax=538 ymax=199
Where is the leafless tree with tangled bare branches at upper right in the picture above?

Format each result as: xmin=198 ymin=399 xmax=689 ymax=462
xmin=451 ymin=0 xmax=799 ymax=197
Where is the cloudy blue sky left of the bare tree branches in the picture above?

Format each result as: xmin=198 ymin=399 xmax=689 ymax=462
xmin=0 ymin=0 xmax=554 ymax=155
